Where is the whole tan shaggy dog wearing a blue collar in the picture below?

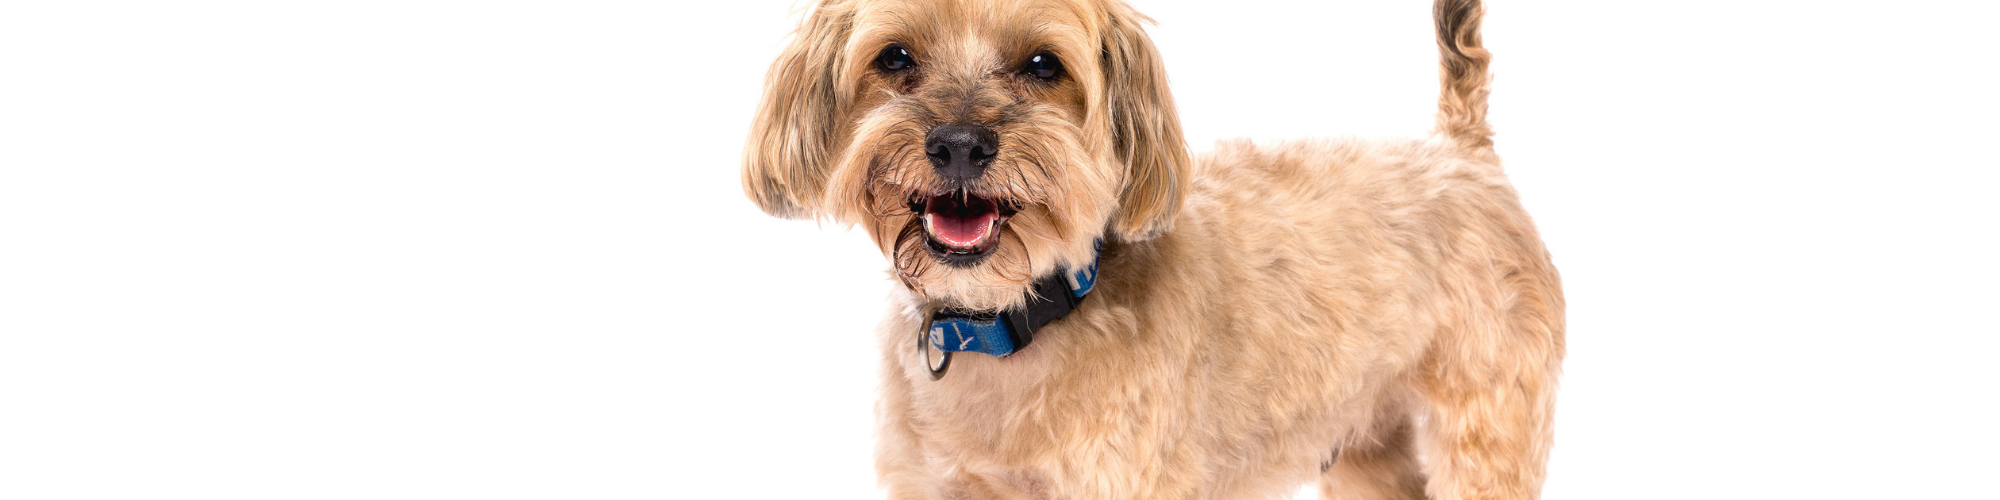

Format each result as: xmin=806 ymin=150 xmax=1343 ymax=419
xmin=742 ymin=0 xmax=1564 ymax=498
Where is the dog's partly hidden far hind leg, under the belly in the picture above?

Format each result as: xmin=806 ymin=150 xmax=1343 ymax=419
xmin=1320 ymin=414 xmax=1424 ymax=500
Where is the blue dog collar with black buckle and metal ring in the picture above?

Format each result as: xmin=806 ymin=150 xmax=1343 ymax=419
xmin=924 ymin=242 xmax=1104 ymax=378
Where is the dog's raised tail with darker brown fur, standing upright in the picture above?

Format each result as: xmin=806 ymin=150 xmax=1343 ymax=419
xmin=1430 ymin=0 xmax=1494 ymax=150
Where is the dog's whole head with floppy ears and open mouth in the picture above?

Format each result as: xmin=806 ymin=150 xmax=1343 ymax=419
xmin=744 ymin=0 xmax=1188 ymax=310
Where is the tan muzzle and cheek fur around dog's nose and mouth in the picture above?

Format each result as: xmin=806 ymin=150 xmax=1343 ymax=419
xmin=828 ymin=96 xmax=1116 ymax=310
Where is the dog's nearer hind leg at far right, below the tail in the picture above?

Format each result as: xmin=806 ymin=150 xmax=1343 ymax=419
xmin=1416 ymin=232 xmax=1564 ymax=500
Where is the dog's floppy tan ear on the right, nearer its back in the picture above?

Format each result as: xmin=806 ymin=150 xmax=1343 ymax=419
xmin=1104 ymin=2 xmax=1190 ymax=242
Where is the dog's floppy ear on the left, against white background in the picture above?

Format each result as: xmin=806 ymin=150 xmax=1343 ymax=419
xmin=744 ymin=6 xmax=852 ymax=218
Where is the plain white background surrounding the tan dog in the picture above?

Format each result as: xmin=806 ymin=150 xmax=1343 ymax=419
xmin=0 ymin=0 xmax=2000 ymax=498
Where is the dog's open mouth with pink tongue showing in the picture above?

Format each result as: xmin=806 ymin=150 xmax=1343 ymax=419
xmin=910 ymin=190 xmax=1018 ymax=264
